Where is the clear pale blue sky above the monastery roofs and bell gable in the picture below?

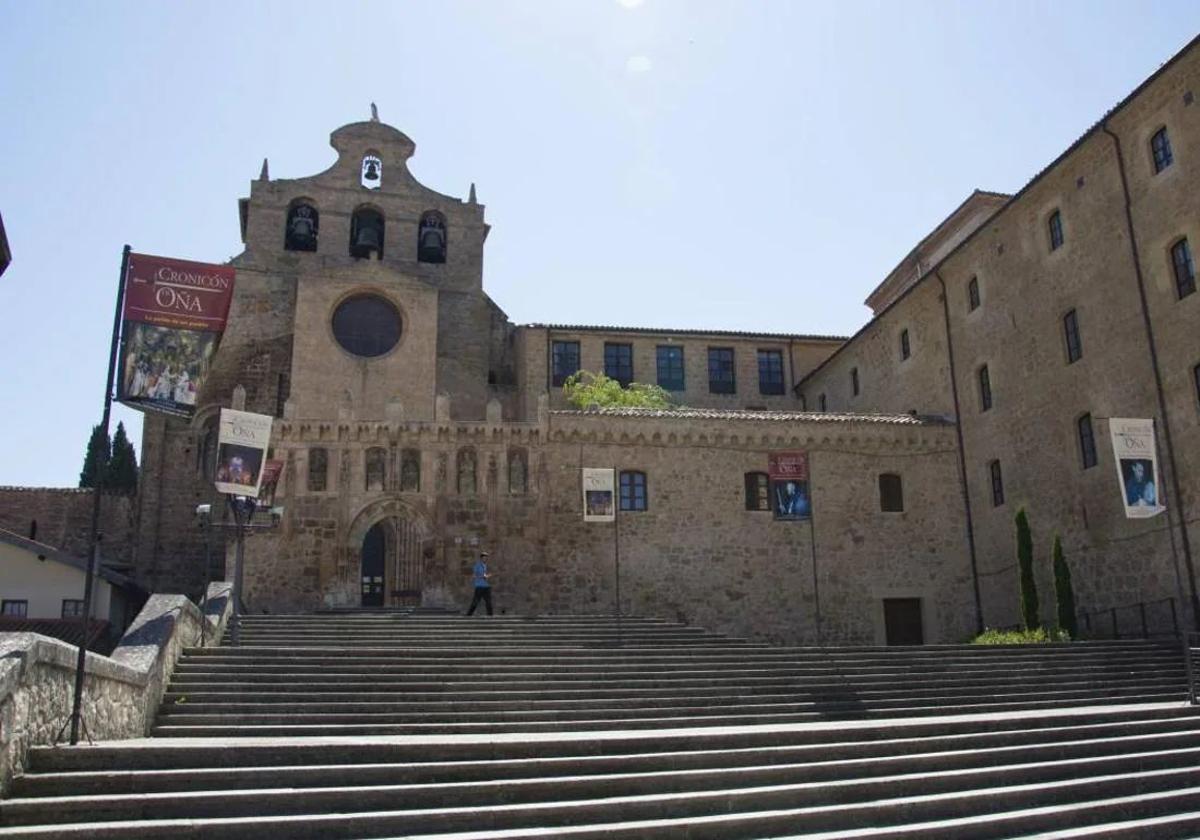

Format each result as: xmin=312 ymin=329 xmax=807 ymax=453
xmin=0 ymin=0 xmax=1200 ymax=486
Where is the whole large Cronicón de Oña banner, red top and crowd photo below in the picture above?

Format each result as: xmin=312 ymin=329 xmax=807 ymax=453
xmin=116 ymin=253 xmax=234 ymax=418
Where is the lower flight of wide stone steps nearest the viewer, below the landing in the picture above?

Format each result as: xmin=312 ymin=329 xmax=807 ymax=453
xmin=7 ymin=707 xmax=1200 ymax=838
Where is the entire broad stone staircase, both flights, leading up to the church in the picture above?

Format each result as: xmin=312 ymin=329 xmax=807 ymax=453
xmin=0 ymin=611 xmax=1200 ymax=840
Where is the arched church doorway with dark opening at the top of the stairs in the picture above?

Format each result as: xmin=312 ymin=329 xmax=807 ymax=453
xmin=360 ymin=516 xmax=424 ymax=607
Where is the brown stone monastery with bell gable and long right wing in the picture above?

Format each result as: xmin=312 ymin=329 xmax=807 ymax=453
xmin=60 ymin=36 xmax=1200 ymax=643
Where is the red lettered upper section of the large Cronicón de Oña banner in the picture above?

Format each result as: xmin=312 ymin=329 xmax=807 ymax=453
xmin=124 ymin=253 xmax=234 ymax=332
